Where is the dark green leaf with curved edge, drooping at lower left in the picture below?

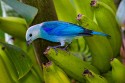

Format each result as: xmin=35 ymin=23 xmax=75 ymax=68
xmin=0 ymin=42 xmax=33 ymax=79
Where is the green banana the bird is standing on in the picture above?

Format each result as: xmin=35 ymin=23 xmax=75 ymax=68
xmin=44 ymin=47 xmax=99 ymax=82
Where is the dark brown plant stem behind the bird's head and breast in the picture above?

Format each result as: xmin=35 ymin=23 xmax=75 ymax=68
xmin=21 ymin=0 xmax=58 ymax=68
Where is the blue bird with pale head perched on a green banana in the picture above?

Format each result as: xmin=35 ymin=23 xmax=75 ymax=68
xmin=26 ymin=21 xmax=110 ymax=48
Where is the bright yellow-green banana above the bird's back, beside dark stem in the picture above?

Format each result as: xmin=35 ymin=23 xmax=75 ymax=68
xmin=53 ymin=0 xmax=76 ymax=23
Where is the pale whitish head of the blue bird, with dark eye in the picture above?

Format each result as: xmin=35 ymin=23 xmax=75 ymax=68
xmin=26 ymin=24 xmax=41 ymax=44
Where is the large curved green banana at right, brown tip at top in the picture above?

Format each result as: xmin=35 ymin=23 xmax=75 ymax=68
xmin=92 ymin=1 xmax=121 ymax=57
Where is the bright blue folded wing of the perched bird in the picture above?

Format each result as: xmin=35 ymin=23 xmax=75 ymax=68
xmin=42 ymin=21 xmax=89 ymax=36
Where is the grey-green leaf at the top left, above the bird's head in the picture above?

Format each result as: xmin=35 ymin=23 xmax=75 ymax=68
xmin=2 ymin=0 xmax=38 ymax=24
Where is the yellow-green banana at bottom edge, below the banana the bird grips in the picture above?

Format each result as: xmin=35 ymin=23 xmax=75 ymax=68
xmin=43 ymin=62 xmax=70 ymax=83
